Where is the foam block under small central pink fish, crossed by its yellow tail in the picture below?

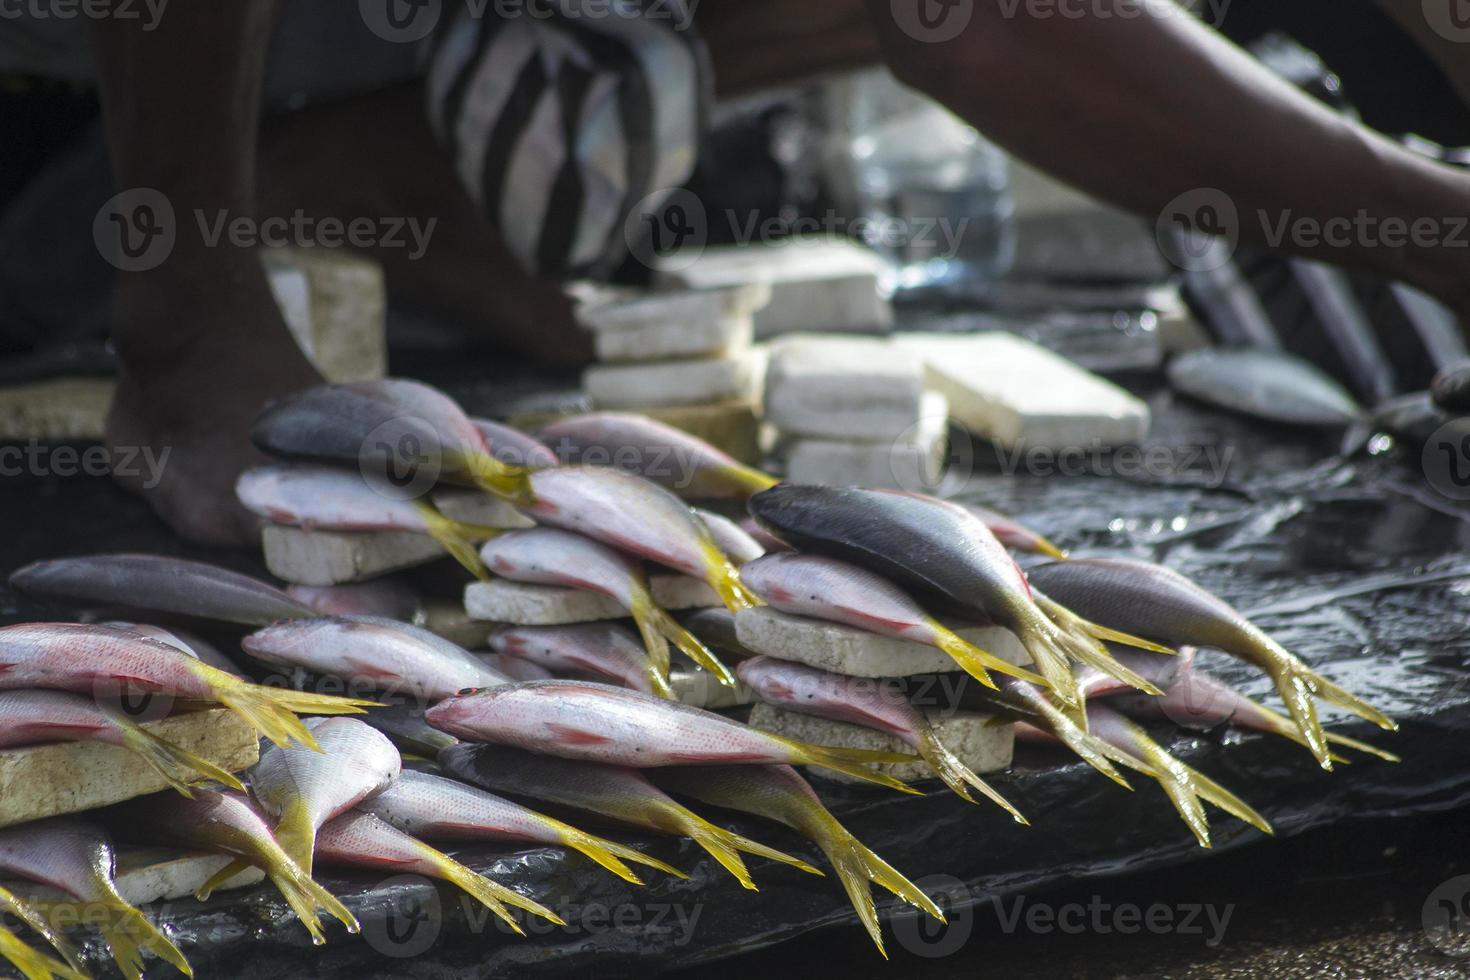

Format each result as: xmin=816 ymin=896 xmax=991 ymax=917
xmin=465 ymin=574 xmax=720 ymax=626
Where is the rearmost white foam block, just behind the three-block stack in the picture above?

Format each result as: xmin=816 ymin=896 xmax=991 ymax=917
xmin=659 ymin=238 xmax=894 ymax=338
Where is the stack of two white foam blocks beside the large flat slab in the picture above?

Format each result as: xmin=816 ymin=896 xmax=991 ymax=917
xmin=764 ymin=335 xmax=948 ymax=491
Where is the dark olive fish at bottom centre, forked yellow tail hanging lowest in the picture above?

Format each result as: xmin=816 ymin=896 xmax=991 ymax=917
xmin=659 ymin=765 xmax=945 ymax=959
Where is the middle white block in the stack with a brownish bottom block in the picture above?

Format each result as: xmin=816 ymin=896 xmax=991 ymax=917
xmin=582 ymin=353 xmax=759 ymax=408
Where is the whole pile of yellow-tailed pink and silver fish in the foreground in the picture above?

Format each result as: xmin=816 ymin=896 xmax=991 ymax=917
xmin=0 ymin=373 xmax=1392 ymax=977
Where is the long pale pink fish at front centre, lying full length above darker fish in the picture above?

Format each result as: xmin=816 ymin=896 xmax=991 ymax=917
xmin=425 ymin=680 xmax=916 ymax=793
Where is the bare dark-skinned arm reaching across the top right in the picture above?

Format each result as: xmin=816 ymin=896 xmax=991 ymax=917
xmin=867 ymin=0 xmax=1470 ymax=314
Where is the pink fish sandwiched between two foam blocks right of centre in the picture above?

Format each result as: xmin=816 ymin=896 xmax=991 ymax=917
xmin=735 ymin=657 xmax=1030 ymax=824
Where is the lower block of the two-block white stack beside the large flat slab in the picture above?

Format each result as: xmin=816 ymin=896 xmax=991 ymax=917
xmin=779 ymin=392 xmax=950 ymax=491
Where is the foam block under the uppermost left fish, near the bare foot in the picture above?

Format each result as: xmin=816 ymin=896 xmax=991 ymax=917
xmin=260 ymin=525 xmax=445 ymax=585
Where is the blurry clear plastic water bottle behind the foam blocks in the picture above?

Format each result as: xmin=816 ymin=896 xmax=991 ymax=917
xmin=850 ymin=72 xmax=1016 ymax=298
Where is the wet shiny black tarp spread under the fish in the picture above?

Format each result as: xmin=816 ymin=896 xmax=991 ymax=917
xmin=0 ymin=395 xmax=1470 ymax=977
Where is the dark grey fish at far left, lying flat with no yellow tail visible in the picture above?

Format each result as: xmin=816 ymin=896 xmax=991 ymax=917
xmin=10 ymin=554 xmax=312 ymax=626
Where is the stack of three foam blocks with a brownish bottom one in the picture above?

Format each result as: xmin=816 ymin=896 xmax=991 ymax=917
xmin=578 ymin=284 xmax=770 ymax=463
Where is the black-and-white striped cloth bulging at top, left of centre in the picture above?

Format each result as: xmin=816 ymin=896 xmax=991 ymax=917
xmin=428 ymin=0 xmax=711 ymax=278
